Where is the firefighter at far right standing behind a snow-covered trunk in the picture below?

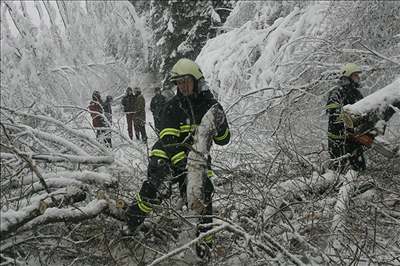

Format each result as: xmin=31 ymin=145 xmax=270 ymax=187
xmin=326 ymin=63 xmax=366 ymax=172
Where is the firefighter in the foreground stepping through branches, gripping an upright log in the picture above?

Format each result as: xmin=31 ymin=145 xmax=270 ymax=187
xmin=128 ymin=58 xmax=230 ymax=257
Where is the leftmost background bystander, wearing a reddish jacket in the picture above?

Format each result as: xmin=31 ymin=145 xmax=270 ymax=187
xmin=88 ymin=91 xmax=111 ymax=147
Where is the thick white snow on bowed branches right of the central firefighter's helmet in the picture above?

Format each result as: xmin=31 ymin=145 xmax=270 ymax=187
xmin=196 ymin=1 xmax=327 ymax=99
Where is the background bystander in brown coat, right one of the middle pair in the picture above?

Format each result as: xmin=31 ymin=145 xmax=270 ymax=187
xmin=133 ymin=87 xmax=147 ymax=142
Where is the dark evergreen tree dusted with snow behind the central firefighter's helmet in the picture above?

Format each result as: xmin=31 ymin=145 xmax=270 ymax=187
xmin=150 ymin=0 xmax=231 ymax=86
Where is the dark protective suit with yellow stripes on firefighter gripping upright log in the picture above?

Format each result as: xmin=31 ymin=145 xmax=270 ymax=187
xmin=128 ymin=90 xmax=230 ymax=230
